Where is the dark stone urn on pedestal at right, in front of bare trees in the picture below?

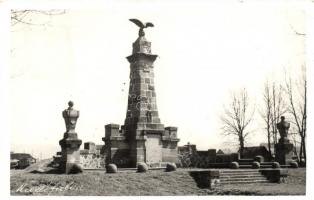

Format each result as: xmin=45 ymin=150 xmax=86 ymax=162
xmin=275 ymin=116 xmax=293 ymax=165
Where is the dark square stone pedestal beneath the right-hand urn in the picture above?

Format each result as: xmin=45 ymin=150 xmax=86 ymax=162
xmin=275 ymin=140 xmax=293 ymax=165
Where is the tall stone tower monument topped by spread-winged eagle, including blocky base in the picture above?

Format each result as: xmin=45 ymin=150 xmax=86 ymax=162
xmin=103 ymin=19 xmax=179 ymax=167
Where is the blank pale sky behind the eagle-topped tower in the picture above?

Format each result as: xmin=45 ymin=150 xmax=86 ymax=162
xmin=9 ymin=1 xmax=306 ymax=157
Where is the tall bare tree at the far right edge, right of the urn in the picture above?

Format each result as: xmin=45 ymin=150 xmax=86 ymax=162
xmin=286 ymin=66 xmax=307 ymax=163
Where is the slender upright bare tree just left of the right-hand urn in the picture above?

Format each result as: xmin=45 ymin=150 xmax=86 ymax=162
xmin=261 ymin=81 xmax=287 ymax=155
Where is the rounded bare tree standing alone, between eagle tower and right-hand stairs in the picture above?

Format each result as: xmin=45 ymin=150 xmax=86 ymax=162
xmin=220 ymin=88 xmax=254 ymax=156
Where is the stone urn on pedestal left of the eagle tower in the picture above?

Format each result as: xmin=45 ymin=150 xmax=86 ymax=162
xmin=59 ymin=101 xmax=82 ymax=174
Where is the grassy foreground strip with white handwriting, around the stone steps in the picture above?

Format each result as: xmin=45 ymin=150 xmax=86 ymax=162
xmin=11 ymin=164 xmax=306 ymax=196
